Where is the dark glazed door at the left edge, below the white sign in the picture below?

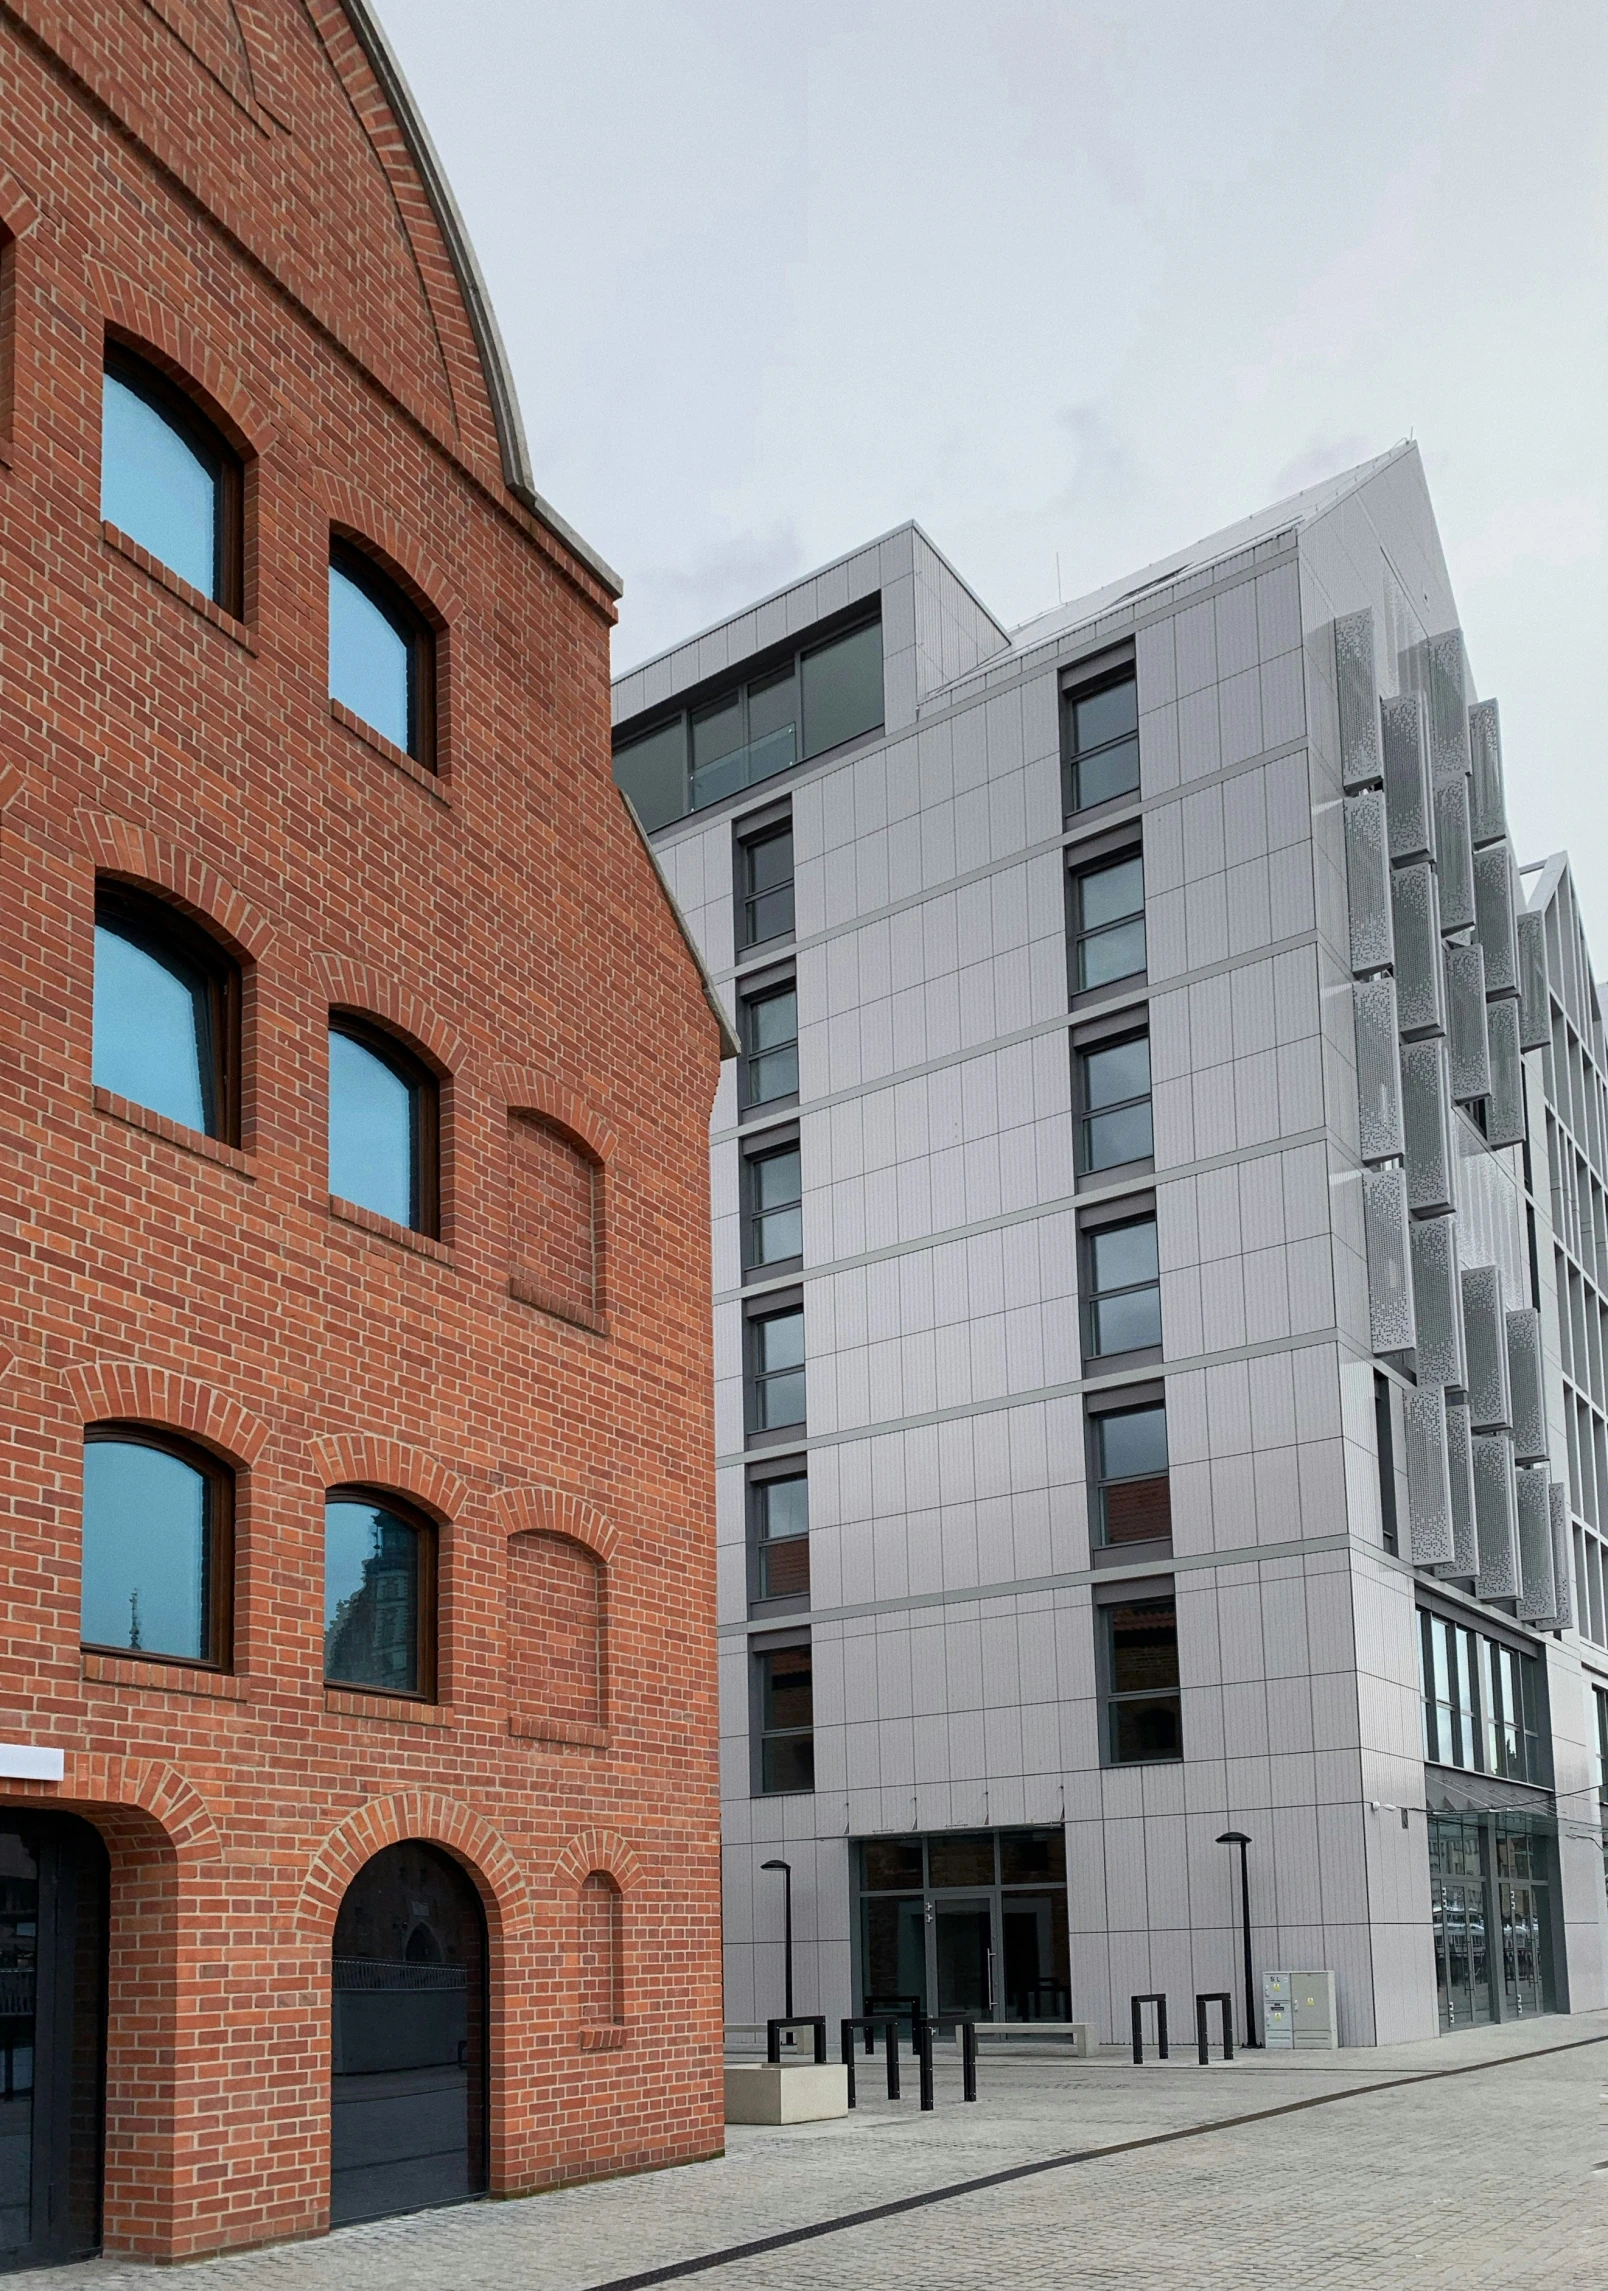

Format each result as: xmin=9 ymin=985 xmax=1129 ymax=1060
xmin=0 ymin=1814 xmax=108 ymax=2268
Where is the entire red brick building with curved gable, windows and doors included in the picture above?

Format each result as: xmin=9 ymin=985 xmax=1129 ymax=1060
xmin=0 ymin=0 xmax=722 ymax=2264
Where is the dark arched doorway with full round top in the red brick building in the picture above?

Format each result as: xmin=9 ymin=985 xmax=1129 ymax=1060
xmin=330 ymin=1837 xmax=486 ymax=2227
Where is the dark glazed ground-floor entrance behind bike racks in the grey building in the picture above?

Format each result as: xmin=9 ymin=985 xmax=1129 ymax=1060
xmin=859 ymin=1828 xmax=1072 ymax=2021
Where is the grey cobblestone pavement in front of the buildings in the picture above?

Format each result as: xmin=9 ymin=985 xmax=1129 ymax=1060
xmin=30 ymin=2014 xmax=1608 ymax=2291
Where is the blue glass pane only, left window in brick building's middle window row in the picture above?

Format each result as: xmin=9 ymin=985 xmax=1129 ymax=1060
xmin=94 ymin=923 xmax=218 ymax=1134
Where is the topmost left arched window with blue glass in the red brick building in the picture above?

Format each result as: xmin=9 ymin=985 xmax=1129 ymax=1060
xmin=101 ymin=346 xmax=241 ymax=612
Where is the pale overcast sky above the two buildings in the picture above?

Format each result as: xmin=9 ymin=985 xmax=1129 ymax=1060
xmin=378 ymin=0 xmax=1608 ymax=939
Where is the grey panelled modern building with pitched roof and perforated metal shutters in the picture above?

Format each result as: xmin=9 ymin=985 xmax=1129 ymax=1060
xmin=614 ymin=444 xmax=1608 ymax=2044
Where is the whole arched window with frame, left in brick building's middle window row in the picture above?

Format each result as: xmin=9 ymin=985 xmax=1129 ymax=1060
xmin=94 ymin=882 xmax=241 ymax=1146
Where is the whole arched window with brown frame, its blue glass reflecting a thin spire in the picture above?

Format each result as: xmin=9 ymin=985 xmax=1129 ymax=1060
xmin=80 ymin=1425 xmax=234 ymax=1668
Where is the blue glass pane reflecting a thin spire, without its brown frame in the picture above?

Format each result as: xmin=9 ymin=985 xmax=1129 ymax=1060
xmin=82 ymin=1439 xmax=211 ymax=1661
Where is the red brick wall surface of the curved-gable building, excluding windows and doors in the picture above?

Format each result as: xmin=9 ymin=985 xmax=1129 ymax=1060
xmin=0 ymin=0 xmax=722 ymax=2259
